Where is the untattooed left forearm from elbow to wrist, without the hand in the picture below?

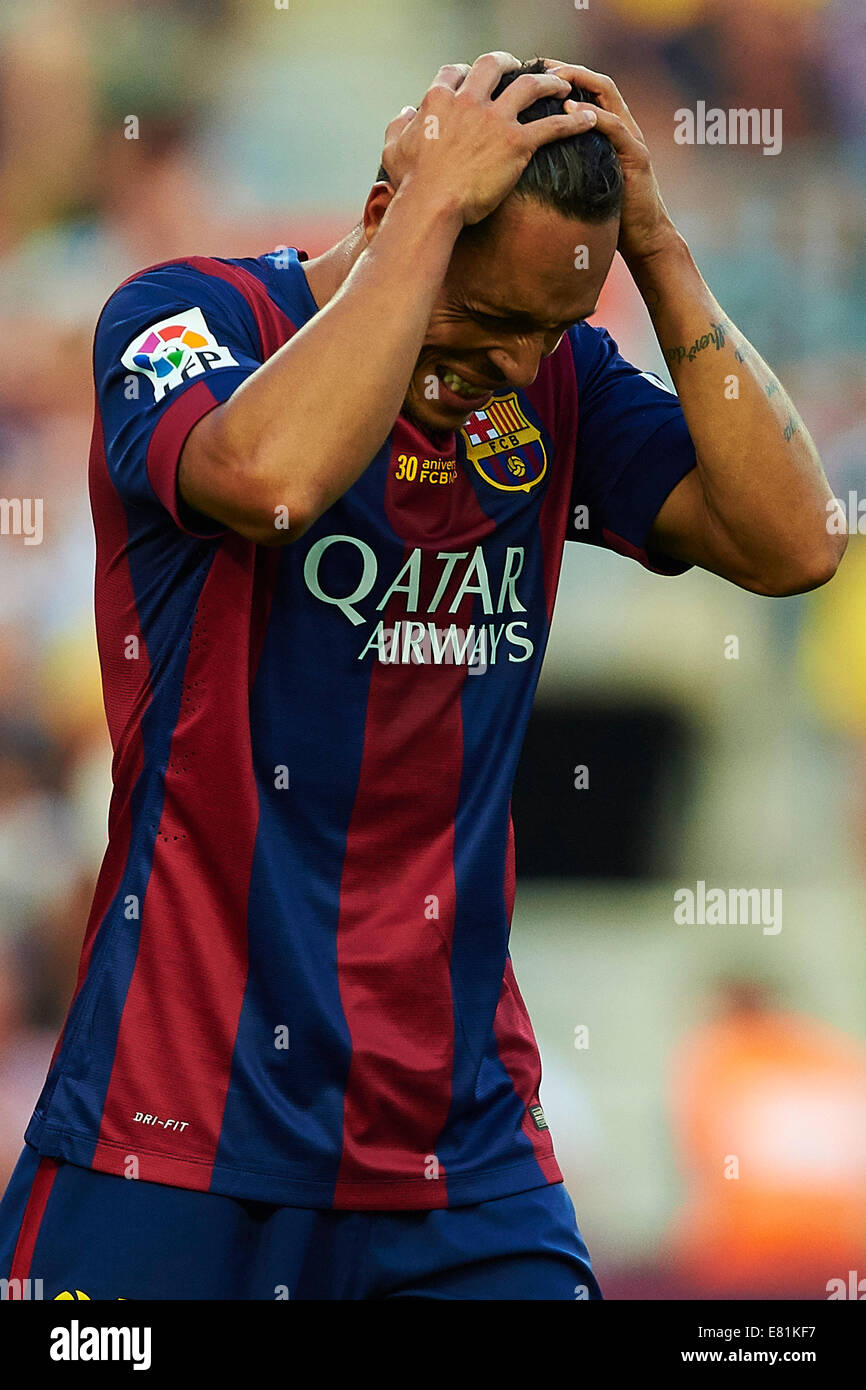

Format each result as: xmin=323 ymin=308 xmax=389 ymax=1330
xmin=181 ymin=179 xmax=461 ymax=541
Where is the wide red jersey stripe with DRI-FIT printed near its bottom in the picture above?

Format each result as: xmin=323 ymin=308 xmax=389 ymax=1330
xmin=93 ymin=534 xmax=259 ymax=1190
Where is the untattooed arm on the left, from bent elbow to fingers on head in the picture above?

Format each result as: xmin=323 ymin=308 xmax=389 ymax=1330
xmin=178 ymin=53 xmax=589 ymax=545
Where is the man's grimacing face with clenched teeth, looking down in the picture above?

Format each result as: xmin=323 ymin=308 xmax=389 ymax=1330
xmin=403 ymin=196 xmax=619 ymax=432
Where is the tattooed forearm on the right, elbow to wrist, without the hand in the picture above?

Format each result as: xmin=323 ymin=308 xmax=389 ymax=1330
xmin=630 ymin=236 xmax=845 ymax=592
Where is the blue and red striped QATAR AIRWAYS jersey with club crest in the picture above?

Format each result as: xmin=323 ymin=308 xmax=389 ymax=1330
xmin=26 ymin=249 xmax=695 ymax=1209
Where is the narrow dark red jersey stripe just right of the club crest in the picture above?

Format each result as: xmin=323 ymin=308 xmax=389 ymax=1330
xmin=527 ymin=338 xmax=577 ymax=623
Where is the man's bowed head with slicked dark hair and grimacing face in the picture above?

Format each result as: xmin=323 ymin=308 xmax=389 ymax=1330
xmin=367 ymin=60 xmax=623 ymax=431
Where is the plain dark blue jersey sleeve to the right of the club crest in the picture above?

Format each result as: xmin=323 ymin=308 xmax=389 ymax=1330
xmin=567 ymin=324 xmax=696 ymax=574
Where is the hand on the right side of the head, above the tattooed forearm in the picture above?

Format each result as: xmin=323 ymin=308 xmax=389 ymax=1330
xmin=545 ymin=58 xmax=677 ymax=264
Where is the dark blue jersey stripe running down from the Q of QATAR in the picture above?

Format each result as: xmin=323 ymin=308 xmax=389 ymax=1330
xmin=215 ymin=438 xmax=405 ymax=1205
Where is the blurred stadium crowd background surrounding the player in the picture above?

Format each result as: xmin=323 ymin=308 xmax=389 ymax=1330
xmin=0 ymin=0 xmax=866 ymax=1298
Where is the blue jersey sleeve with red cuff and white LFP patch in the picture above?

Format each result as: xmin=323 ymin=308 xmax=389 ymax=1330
xmin=93 ymin=263 xmax=263 ymax=539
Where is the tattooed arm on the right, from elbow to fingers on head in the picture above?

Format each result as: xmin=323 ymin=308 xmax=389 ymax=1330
xmin=552 ymin=64 xmax=847 ymax=595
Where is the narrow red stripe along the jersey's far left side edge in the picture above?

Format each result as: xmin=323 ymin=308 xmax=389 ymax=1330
xmin=51 ymin=404 xmax=150 ymax=1066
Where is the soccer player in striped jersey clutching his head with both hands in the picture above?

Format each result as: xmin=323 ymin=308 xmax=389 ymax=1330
xmin=0 ymin=53 xmax=844 ymax=1300
